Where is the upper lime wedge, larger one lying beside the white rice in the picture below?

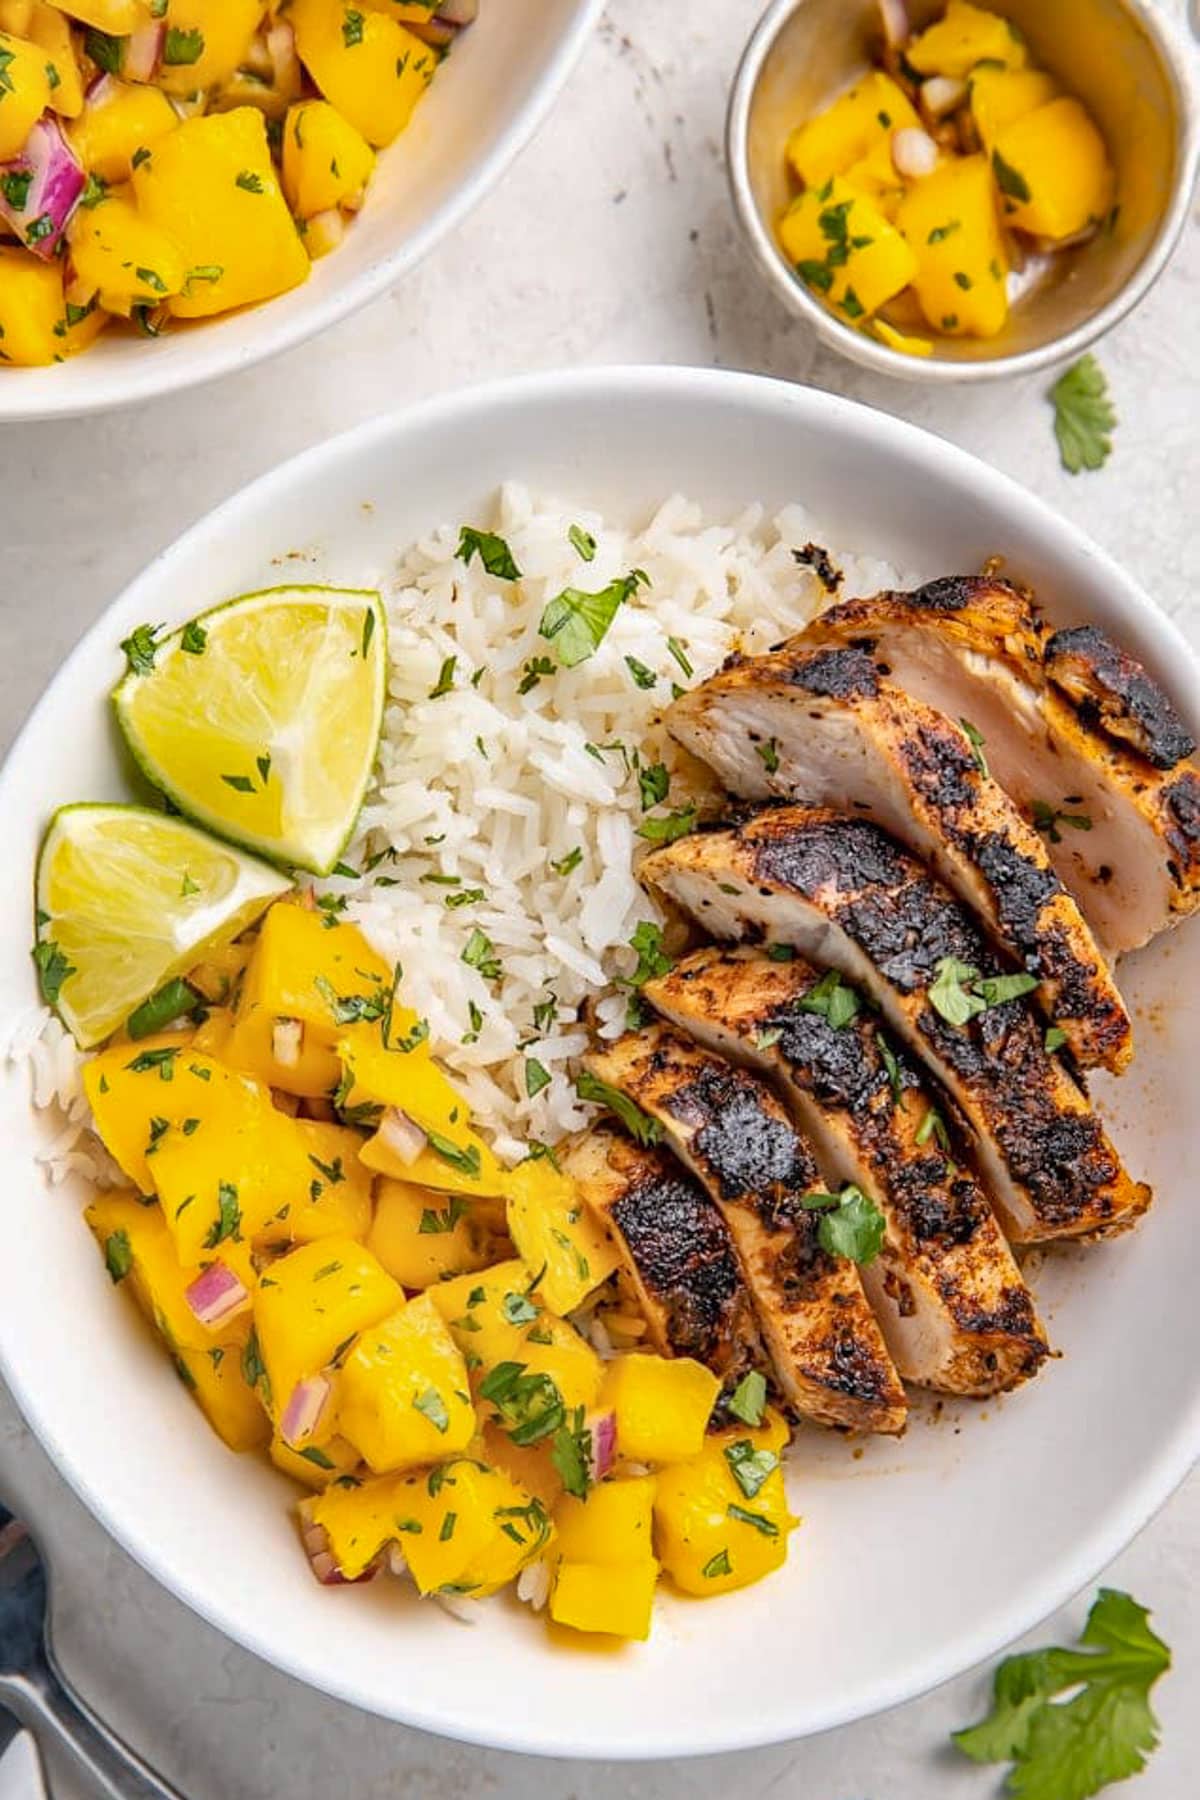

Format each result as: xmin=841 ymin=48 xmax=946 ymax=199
xmin=113 ymin=587 xmax=387 ymax=875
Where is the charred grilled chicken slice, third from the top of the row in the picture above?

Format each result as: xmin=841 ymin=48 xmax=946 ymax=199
xmin=639 ymin=806 xmax=1150 ymax=1244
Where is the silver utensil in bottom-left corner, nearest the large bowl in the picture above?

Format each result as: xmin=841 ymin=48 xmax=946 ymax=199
xmin=0 ymin=1507 xmax=182 ymax=1800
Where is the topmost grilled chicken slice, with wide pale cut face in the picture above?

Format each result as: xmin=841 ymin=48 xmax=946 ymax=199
xmin=792 ymin=576 xmax=1200 ymax=956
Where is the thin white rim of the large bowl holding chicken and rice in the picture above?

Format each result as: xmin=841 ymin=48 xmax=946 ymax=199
xmin=0 ymin=364 xmax=1200 ymax=1762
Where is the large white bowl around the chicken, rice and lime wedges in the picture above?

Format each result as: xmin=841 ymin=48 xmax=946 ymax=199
xmin=0 ymin=369 xmax=1200 ymax=1757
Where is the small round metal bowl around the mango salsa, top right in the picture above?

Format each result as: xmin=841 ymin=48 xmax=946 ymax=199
xmin=727 ymin=0 xmax=1200 ymax=382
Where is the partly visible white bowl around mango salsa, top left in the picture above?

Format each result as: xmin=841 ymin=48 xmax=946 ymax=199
xmin=0 ymin=0 xmax=604 ymax=425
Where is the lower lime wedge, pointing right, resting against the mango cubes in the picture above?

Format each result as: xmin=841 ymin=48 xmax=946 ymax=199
xmin=34 ymin=806 xmax=290 ymax=1049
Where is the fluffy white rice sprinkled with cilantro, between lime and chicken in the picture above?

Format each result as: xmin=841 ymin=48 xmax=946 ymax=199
xmin=9 ymin=482 xmax=907 ymax=1186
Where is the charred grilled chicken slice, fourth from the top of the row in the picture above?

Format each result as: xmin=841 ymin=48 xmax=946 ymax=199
xmin=642 ymin=949 xmax=1049 ymax=1395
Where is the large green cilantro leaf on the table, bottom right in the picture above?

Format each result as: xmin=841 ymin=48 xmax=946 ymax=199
xmin=954 ymin=1588 xmax=1171 ymax=1800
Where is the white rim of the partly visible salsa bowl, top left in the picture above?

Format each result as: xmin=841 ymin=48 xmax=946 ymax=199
xmin=0 ymin=0 xmax=604 ymax=427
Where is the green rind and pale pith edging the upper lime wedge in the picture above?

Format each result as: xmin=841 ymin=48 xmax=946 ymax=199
xmin=112 ymin=583 xmax=387 ymax=875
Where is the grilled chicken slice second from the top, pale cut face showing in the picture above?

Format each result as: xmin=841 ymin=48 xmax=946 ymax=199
xmin=666 ymin=646 xmax=1133 ymax=1069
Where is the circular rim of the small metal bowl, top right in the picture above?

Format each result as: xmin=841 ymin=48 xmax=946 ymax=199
xmin=725 ymin=0 xmax=1200 ymax=383
